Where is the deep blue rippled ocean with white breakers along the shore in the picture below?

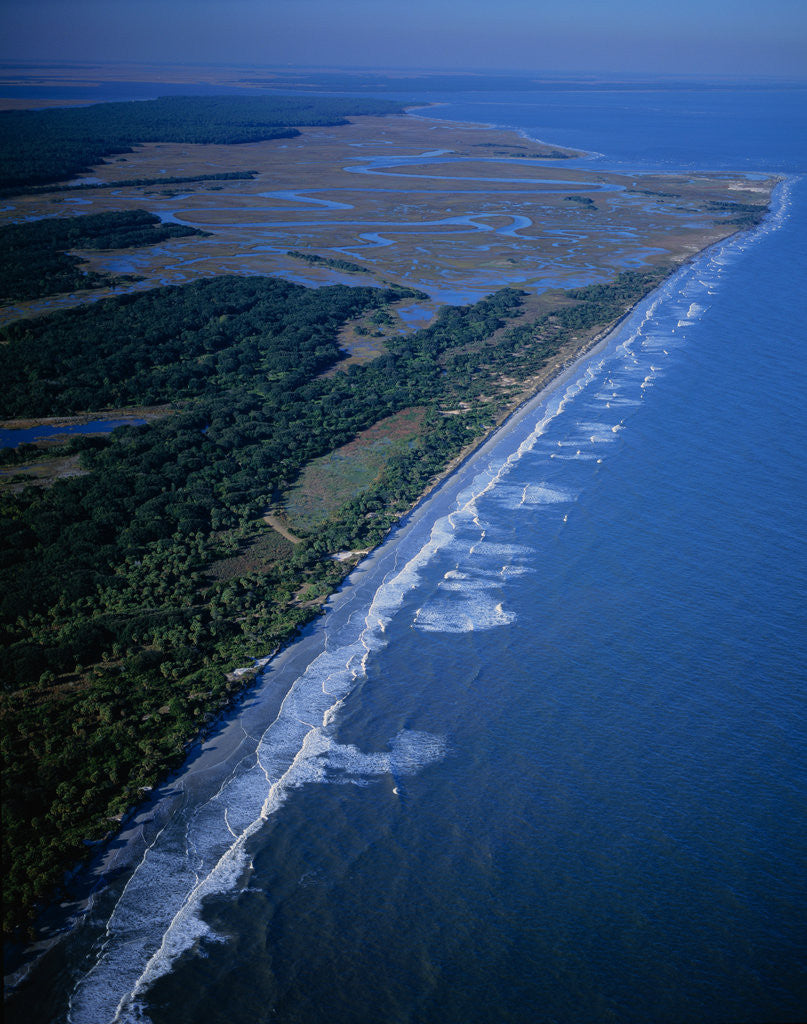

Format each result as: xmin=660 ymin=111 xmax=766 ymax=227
xmin=10 ymin=81 xmax=807 ymax=1024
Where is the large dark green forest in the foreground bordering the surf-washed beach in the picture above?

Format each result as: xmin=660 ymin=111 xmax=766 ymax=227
xmin=0 ymin=273 xmax=656 ymax=928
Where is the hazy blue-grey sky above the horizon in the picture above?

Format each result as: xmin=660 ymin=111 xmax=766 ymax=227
xmin=0 ymin=0 xmax=807 ymax=77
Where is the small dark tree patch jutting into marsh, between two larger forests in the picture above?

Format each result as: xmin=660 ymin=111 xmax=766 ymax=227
xmin=0 ymin=210 xmax=204 ymax=304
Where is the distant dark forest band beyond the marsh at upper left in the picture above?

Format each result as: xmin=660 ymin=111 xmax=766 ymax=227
xmin=0 ymin=96 xmax=401 ymax=188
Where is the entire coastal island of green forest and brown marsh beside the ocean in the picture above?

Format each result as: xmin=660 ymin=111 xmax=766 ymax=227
xmin=0 ymin=96 xmax=775 ymax=935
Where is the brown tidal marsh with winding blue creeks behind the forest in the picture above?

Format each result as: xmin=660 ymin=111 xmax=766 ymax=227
xmin=0 ymin=114 xmax=773 ymax=323
